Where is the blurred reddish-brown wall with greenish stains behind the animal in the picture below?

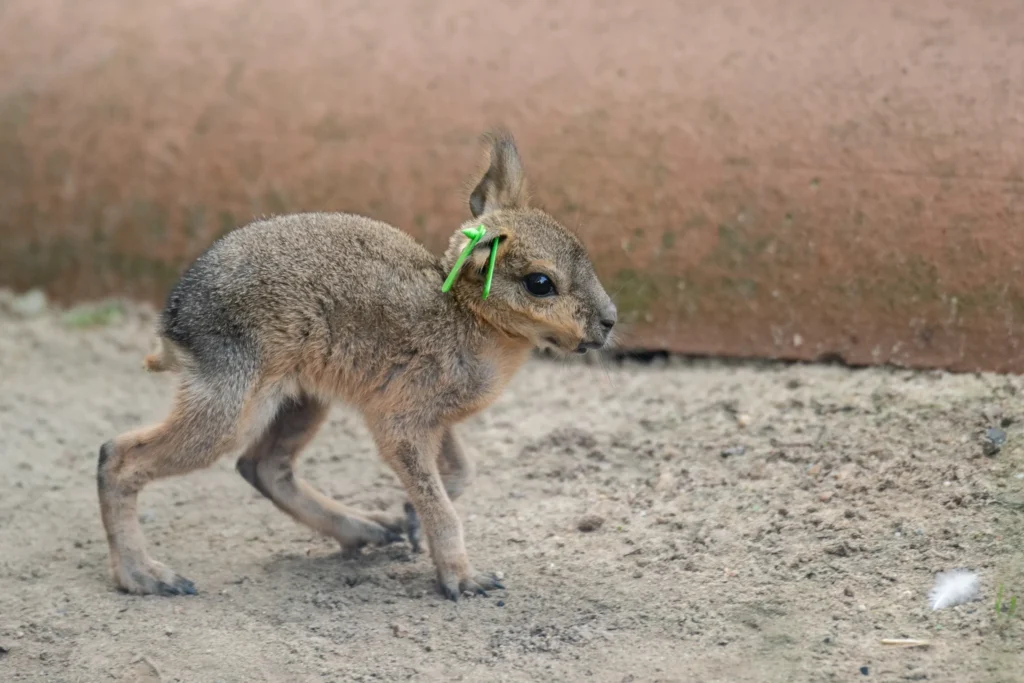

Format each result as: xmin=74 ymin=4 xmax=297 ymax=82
xmin=0 ymin=0 xmax=1024 ymax=371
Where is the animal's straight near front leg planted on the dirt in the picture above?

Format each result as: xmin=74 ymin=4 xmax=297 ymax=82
xmin=374 ymin=429 xmax=504 ymax=600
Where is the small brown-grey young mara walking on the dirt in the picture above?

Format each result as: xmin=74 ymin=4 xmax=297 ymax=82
xmin=97 ymin=125 xmax=615 ymax=599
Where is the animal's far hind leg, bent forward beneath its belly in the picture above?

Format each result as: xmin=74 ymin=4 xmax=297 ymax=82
xmin=238 ymin=395 xmax=402 ymax=552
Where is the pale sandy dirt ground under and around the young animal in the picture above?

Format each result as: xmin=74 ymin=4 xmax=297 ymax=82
xmin=0 ymin=294 xmax=1024 ymax=683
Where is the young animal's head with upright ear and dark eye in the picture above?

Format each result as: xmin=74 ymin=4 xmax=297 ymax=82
xmin=444 ymin=130 xmax=617 ymax=352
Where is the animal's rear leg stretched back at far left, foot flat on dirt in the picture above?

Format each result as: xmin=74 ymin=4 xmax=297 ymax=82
xmin=96 ymin=383 xmax=253 ymax=595
